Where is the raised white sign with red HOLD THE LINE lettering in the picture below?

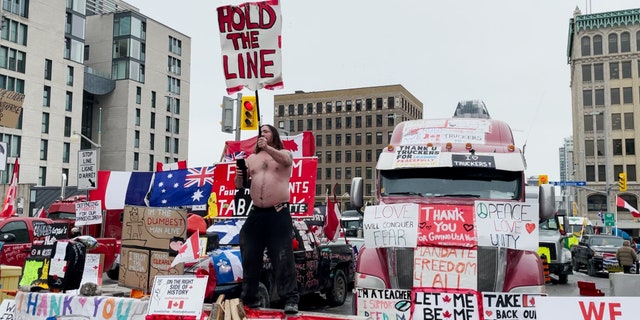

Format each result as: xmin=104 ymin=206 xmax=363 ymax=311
xmin=217 ymin=1 xmax=284 ymax=95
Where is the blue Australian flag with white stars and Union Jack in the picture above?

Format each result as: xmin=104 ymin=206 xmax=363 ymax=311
xmin=149 ymin=166 xmax=215 ymax=207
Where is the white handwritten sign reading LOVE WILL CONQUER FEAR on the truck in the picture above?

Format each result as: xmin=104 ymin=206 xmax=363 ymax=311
xmin=363 ymin=203 xmax=419 ymax=248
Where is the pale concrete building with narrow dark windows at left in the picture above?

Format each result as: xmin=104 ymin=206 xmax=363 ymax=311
xmin=0 ymin=0 xmax=191 ymax=215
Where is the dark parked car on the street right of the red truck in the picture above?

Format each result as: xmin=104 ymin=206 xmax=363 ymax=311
xmin=571 ymin=234 xmax=624 ymax=276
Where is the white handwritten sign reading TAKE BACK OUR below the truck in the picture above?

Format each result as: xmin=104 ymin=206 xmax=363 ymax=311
xmin=482 ymin=292 xmax=542 ymax=320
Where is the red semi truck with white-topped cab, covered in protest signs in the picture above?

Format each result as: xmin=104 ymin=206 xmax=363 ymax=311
xmin=351 ymin=101 xmax=555 ymax=314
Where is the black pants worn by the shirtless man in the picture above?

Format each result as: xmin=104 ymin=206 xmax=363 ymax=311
xmin=240 ymin=206 xmax=300 ymax=305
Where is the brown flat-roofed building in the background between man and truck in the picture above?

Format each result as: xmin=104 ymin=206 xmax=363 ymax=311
xmin=273 ymin=85 xmax=423 ymax=206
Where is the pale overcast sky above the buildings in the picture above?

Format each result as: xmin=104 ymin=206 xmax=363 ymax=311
xmin=127 ymin=0 xmax=640 ymax=181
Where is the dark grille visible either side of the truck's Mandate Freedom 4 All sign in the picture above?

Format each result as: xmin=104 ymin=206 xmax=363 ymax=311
xmin=387 ymin=247 xmax=507 ymax=292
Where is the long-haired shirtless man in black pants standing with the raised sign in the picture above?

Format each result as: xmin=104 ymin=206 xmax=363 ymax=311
xmin=234 ymin=125 xmax=300 ymax=313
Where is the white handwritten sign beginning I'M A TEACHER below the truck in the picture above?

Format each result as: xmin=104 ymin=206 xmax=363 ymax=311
xmin=356 ymin=288 xmax=412 ymax=319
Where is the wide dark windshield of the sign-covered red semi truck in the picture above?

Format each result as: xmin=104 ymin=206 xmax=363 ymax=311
xmin=380 ymin=167 xmax=523 ymax=200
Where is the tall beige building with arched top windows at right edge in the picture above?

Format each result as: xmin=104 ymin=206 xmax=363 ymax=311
xmin=567 ymin=8 xmax=640 ymax=235
